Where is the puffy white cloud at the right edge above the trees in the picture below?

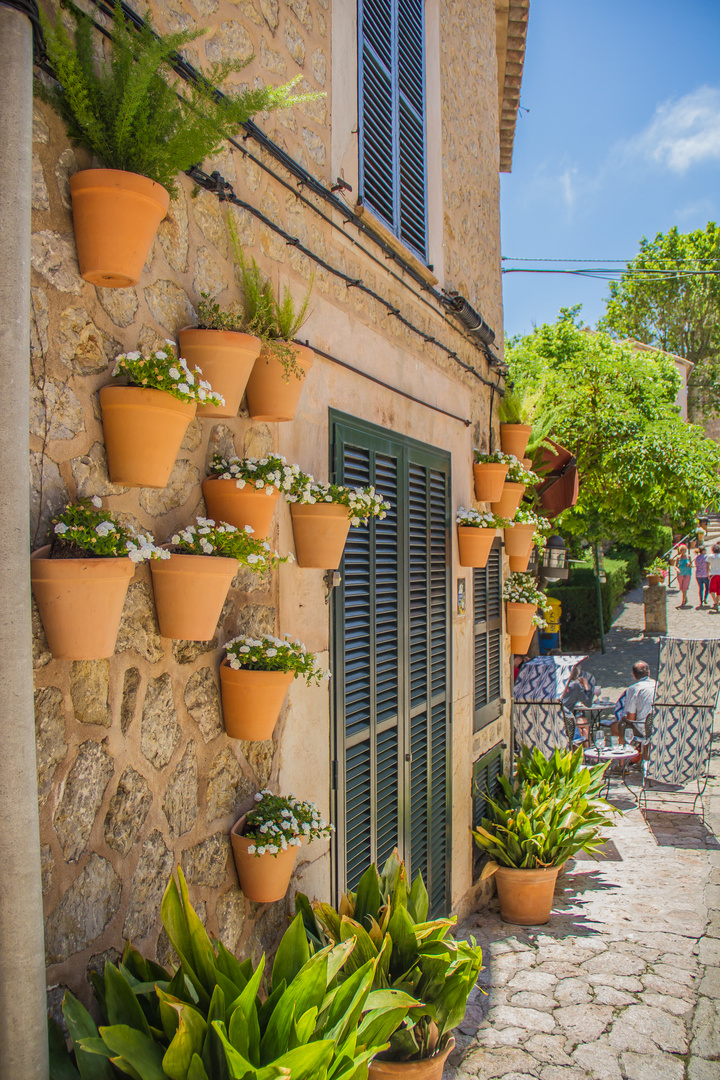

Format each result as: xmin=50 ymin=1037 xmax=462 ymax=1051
xmin=633 ymin=86 xmax=720 ymax=173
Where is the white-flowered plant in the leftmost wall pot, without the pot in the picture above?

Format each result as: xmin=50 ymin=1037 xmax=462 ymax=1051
xmin=51 ymin=496 xmax=169 ymax=563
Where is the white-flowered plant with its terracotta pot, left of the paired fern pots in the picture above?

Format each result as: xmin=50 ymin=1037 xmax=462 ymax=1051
xmin=100 ymin=341 xmax=222 ymax=487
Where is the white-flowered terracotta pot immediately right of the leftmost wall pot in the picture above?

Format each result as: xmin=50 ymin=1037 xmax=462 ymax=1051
xmin=151 ymin=517 xmax=293 ymax=642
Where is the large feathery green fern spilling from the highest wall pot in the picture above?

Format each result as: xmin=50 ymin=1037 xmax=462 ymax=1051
xmin=36 ymin=4 xmax=322 ymax=198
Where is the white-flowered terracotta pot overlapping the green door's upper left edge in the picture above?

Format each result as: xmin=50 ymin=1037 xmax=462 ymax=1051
xmin=285 ymin=473 xmax=391 ymax=570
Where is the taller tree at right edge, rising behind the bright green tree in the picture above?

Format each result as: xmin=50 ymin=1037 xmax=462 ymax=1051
xmin=598 ymin=221 xmax=720 ymax=416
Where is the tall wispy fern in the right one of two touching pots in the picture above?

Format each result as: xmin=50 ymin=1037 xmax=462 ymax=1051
xmin=228 ymin=214 xmax=315 ymax=382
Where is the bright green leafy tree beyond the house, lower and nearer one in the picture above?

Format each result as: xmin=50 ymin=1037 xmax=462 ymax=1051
xmin=506 ymin=308 xmax=720 ymax=548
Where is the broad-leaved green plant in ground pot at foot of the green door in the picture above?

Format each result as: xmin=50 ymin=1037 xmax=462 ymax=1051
xmin=295 ymin=851 xmax=483 ymax=1080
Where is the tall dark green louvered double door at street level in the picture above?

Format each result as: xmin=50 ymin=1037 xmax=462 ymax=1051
xmin=331 ymin=415 xmax=450 ymax=913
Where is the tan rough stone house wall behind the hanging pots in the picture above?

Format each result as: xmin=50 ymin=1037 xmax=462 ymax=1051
xmin=30 ymin=0 xmax=518 ymax=1000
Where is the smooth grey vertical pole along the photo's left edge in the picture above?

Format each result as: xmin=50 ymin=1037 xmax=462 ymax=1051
xmin=0 ymin=0 xmax=47 ymax=1080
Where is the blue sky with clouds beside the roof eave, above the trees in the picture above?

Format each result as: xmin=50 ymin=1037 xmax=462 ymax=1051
xmin=501 ymin=0 xmax=720 ymax=335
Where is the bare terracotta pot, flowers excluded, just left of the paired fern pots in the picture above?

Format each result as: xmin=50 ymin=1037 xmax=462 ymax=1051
xmin=100 ymin=387 xmax=195 ymax=487
